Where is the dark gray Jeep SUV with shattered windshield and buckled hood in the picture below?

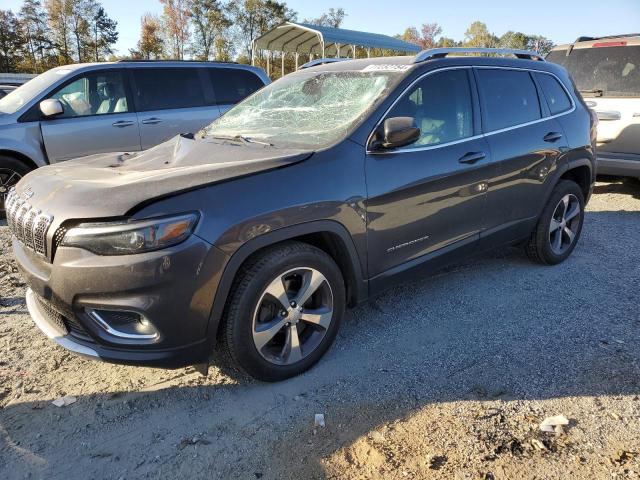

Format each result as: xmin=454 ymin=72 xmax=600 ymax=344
xmin=8 ymin=49 xmax=595 ymax=381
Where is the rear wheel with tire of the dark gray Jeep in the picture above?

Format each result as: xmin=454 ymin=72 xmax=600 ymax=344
xmin=525 ymin=180 xmax=584 ymax=265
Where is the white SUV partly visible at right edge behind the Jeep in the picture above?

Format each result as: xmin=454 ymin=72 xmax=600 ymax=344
xmin=547 ymin=34 xmax=640 ymax=177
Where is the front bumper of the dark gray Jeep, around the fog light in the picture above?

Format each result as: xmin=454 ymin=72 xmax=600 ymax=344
xmin=13 ymin=236 xmax=227 ymax=368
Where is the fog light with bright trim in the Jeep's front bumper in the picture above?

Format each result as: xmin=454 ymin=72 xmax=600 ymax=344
xmin=86 ymin=308 xmax=159 ymax=342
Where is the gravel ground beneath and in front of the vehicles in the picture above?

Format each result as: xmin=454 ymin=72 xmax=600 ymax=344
xmin=0 ymin=181 xmax=640 ymax=479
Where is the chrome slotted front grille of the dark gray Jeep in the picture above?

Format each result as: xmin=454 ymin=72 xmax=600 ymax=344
xmin=5 ymin=188 xmax=53 ymax=257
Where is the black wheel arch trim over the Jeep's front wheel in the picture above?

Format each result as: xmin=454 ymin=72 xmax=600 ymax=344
xmin=208 ymin=220 xmax=368 ymax=340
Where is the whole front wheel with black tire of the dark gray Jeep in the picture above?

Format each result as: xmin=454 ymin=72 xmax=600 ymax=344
xmin=220 ymin=242 xmax=346 ymax=382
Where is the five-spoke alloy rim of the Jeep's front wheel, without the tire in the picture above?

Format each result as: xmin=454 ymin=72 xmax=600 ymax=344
xmin=252 ymin=267 xmax=333 ymax=365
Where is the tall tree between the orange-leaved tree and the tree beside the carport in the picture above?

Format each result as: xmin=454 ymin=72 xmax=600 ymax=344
xmin=190 ymin=0 xmax=231 ymax=60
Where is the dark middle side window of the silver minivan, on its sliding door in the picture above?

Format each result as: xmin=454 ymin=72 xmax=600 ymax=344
xmin=132 ymin=68 xmax=206 ymax=112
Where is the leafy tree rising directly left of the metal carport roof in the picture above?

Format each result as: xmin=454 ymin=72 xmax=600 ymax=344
xmin=229 ymin=0 xmax=297 ymax=58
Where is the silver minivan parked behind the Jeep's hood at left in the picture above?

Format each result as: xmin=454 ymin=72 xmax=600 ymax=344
xmin=0 ymin=62 xmax=269 ymax=214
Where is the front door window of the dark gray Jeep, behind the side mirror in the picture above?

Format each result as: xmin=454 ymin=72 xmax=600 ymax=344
xmin=388 ymin=69 xmax=473 ymax=148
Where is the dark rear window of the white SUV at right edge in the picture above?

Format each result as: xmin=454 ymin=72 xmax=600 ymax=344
xmin=547 ymin=45 xmax=640 ymax=97
